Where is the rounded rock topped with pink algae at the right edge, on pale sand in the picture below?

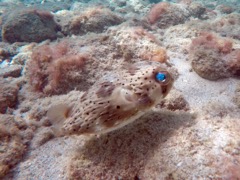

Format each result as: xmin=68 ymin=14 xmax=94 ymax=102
xmin=190 ymin=33 xmax=240 ymax=80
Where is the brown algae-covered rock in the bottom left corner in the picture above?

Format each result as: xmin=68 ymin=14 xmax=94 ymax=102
xmin=0 ymin=113 xmax=33 ymax=179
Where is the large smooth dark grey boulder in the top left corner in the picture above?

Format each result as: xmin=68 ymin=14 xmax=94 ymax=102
xmin=2 ymin=9 xmax=59 ymax=43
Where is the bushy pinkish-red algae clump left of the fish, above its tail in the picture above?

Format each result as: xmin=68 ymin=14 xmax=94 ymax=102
xmin=26 ymin=41 xmax=88 ymax=94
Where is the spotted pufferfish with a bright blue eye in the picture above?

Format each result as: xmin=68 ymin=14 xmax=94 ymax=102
xmin=47 ymin=62 xmax=174 ymax=135
